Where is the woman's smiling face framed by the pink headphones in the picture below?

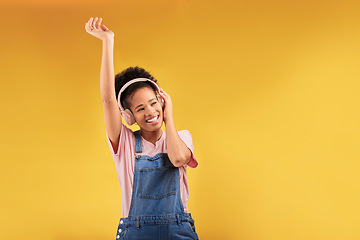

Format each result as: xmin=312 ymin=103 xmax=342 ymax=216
xmin=129 ymin=87 xmax=163 ymax=131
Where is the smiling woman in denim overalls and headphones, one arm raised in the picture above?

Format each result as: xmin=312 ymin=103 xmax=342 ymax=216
xmin=85 ymin=17 xmax=198 ymax=240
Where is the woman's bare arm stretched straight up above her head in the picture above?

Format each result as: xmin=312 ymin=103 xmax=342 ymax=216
xmin=85 ymin=17 xmax=121 ymax=153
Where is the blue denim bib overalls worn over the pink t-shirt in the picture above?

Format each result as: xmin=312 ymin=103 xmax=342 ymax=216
xmin=116 ymin=130 xmax=199 ymax=240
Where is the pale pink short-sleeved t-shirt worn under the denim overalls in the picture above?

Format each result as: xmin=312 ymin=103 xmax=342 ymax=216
xmin=106 ymin=123 xmax=198 ymax=218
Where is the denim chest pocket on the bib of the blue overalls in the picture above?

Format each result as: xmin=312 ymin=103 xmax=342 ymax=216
xmin=139 ymin=166 xmax=178 ymax=199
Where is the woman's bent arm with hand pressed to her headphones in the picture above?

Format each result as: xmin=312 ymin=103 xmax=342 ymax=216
xmin=160 ymin=88 xmax=191 ymax=167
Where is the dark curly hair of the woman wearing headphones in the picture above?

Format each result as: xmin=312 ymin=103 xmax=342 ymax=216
xmin=115 ymin=66 xmax=159 ymax=109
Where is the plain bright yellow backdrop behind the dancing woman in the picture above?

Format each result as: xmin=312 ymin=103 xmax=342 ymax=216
xmin=0 ymin=0 xmax=360 ymax=240
